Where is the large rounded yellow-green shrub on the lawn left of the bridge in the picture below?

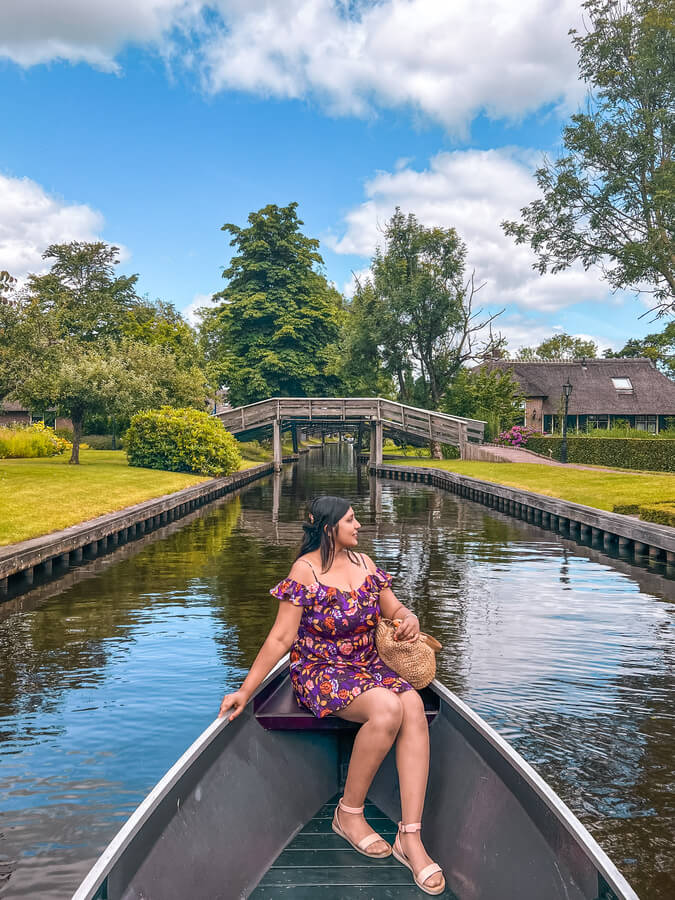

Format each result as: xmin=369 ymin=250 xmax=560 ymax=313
xmin=125 ymin=406 xmax=241 ymax=475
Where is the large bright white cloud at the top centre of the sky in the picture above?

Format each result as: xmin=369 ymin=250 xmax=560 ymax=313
xmin=204 ymin=0 xmax=579 ymax=131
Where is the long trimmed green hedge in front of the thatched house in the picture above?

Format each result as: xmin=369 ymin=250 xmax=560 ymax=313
xmin=527 ymin=434 xmax=675 ymax=472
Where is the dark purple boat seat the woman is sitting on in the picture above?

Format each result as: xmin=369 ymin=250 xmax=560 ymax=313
xmin=253 ymin=678 xmax=440 ymax=731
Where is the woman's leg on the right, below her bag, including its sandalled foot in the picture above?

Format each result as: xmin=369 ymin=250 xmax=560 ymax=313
xmin=396 ymin=691 xmax=443 ymax=887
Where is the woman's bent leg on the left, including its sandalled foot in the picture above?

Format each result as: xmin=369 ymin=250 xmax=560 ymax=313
xmin=335 ymin=688 xmax=403 ymax=854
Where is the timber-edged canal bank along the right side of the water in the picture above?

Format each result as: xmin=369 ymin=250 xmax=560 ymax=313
xmin=369 ymin=463 xmax=675 ymax=577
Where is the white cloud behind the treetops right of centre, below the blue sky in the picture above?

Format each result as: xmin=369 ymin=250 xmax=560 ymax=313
xmin=326 ymin=148 xmax=607 ymax=312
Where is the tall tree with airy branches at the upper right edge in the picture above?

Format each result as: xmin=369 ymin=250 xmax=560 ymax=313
xmin=502 ymin=0 xmax=675 ymax=314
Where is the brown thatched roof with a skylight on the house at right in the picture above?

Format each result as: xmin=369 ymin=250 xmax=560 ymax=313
xmin=484 ymin=358 xmax=675 ymax=416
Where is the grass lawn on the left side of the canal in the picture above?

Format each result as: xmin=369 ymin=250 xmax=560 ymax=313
xmin=0 ymin=450 xmax=260 ymax=545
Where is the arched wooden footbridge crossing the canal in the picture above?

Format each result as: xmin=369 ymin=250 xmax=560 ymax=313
xmin=216 ymin=397 xmax=485 ymax=469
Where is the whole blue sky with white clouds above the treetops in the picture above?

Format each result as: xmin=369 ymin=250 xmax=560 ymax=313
xmin=0 ymin=0 xmax=661 ymax=352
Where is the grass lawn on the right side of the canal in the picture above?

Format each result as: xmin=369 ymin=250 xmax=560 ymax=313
xmin=395 ymin=458 xmax=675 ymax=512
